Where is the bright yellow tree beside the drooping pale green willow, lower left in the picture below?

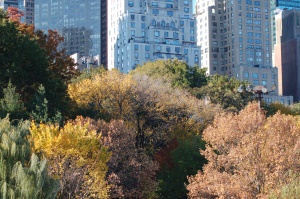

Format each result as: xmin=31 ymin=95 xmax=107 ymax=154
xmin=29 ymin=118 xmax=110 ymax=198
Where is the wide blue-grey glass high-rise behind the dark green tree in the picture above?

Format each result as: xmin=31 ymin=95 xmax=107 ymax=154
xmin=35 ymin=0 xmax=107 ymax=66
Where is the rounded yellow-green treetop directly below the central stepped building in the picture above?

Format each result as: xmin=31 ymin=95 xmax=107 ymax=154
xmin=131 ymin=60 xmax=207 ymax=88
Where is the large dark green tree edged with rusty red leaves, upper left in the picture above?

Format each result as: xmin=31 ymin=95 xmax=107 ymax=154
xmin=0 ymin=9 xmax=78 ymax=119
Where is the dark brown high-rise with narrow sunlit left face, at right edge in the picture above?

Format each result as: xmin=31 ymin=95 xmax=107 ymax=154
xmin=274 ymin=9 xmax=300 ymax=102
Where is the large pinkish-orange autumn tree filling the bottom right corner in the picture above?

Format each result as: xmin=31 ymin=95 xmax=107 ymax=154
xmin=187 ymin=104 xmax=300 ymax=198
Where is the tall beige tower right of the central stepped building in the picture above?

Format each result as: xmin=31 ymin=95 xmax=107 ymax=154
xmin=196 ymin=0 xmax=277 ymax=90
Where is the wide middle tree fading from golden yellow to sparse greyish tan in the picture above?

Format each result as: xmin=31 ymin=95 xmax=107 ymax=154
xmin=69 ymin=70 xmax=218 ymax=150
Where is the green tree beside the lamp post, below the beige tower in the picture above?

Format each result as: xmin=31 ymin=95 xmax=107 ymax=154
xmin=196 ymin=75 xmax=254 ymax=111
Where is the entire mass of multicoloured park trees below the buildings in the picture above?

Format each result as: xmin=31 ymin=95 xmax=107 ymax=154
xmin=0 ymin=9 xmax=300 ymax=199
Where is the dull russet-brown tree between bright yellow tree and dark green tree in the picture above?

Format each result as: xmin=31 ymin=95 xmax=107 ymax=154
xmin=89 ymin=120 xmax=158 ymax=198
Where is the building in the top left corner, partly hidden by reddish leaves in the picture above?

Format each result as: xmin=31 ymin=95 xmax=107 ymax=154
xmin=0 ymin=0 xmax=34 ymax=24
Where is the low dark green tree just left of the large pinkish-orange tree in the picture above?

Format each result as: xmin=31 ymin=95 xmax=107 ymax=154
xmin=155 ymin=136 xmax=206 ymax=199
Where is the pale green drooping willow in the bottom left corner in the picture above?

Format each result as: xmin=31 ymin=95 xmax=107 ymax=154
xmin=0 ymin=118 xmax=59 ymax=199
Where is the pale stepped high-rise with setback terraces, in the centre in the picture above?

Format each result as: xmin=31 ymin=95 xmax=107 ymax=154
xmin=107 ymin=0 xmax=200 ymax=73
